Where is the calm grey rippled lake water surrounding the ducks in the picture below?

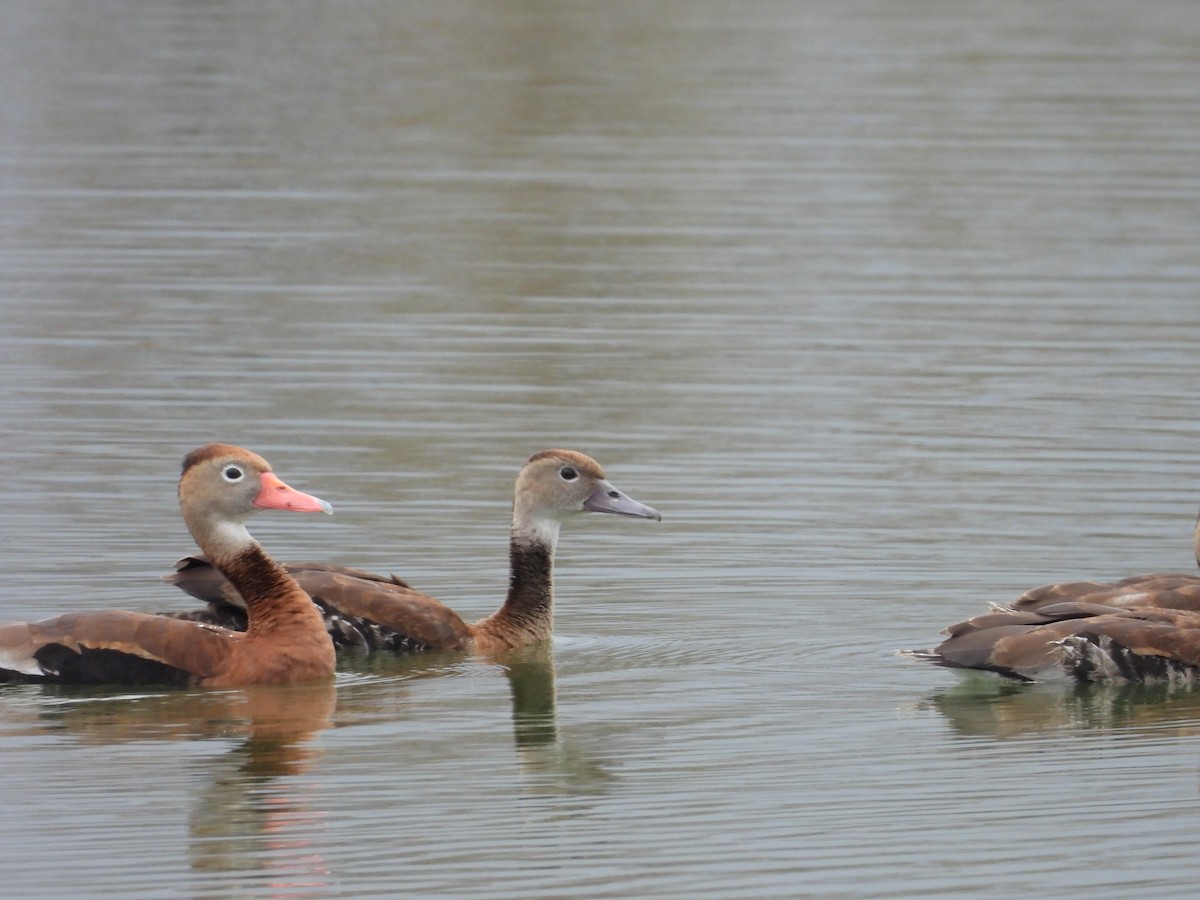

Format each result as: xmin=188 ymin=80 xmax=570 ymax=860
xmin=0 ymin=0 xmax=1200 ymax=898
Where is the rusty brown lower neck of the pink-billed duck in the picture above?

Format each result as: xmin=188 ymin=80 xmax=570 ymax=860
xmin=214 ymin=544 xmax=325 ymax=635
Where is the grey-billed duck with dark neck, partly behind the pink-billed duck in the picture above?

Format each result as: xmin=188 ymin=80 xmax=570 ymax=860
xmin=164 ymin=450 xmax=662 ymax=653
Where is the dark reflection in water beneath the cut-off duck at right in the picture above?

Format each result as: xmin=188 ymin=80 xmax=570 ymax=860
xmin=920 ymin=678 xmax=1200 ymax=740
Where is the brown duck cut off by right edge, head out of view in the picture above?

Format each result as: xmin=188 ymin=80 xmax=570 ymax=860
xmin=910 ymin=508 xmax=1200 ymax=683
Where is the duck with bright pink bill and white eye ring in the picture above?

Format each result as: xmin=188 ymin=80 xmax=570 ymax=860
xmin=0 ymin=444 xmax=334 ymax=688
